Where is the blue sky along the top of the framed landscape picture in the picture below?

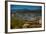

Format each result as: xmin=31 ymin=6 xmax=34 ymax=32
xmin=11 ymin=5 xmax=41 ymax=11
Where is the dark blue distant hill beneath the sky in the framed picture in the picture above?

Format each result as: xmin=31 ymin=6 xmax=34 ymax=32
xmin=11 ymin=9 xmax=42 ymax=14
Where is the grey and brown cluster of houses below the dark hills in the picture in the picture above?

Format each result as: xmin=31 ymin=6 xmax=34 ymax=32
xmin=12 ymin=11 xmax=42 ymax=28
